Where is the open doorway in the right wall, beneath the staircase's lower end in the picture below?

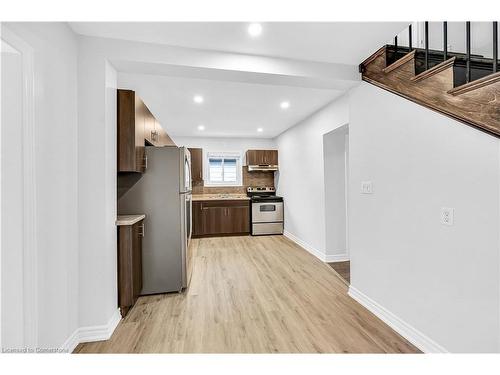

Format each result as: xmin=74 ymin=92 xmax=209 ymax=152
xmin=323 ymin=124 xmax=350 ymax=283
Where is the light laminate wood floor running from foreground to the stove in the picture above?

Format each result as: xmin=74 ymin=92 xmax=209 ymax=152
xmin=75 ymin=236 xmax=418 ymax=353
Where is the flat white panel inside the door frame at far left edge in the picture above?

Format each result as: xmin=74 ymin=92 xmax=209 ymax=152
xmin=0 ymin=36 xmax=24 ymax=348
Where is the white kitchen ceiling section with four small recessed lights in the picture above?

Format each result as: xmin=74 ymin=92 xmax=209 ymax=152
xmin=118 ymin=73 xmax=342 ymax=138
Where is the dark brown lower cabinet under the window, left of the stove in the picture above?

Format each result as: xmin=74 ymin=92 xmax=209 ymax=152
xmin=193 ymin=200 xmax=250 ymax=237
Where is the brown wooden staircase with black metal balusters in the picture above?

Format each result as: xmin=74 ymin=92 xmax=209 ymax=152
xmin=360 ymin=22 xmax=500 ymax=137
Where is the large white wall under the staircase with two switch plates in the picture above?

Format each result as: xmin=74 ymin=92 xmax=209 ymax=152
xmin=349 ymin=83 xmax=500 ymax=352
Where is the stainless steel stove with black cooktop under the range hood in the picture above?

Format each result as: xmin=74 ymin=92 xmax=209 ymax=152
xmin=247 ymin=187 xmax=283 ymax=236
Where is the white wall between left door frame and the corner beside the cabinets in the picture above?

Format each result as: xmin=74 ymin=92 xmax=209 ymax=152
xmin=2 ymin=23 xmax=78 ymax=348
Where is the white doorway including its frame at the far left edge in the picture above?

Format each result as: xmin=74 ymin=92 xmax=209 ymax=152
xmin=0 ymin=25 xmax=37 ymax=350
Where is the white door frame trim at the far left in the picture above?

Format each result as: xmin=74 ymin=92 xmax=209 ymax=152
xmin=0 ymin=24 xmax=38 ymax=349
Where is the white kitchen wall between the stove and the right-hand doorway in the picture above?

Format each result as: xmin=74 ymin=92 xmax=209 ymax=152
xmin=276 ymin=96 xmax=349 ymax=260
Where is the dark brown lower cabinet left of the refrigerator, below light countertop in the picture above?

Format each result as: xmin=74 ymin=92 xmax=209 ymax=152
xmin=118 ymin=220 xmax=144 ymax=317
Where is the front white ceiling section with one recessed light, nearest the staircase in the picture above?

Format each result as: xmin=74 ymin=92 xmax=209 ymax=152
xmin=70 ymin=22 xmax=408 ymax=65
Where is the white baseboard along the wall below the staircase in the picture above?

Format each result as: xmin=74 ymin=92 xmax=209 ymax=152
xmin=348 ymin=285 xmax=448 ymax=353
